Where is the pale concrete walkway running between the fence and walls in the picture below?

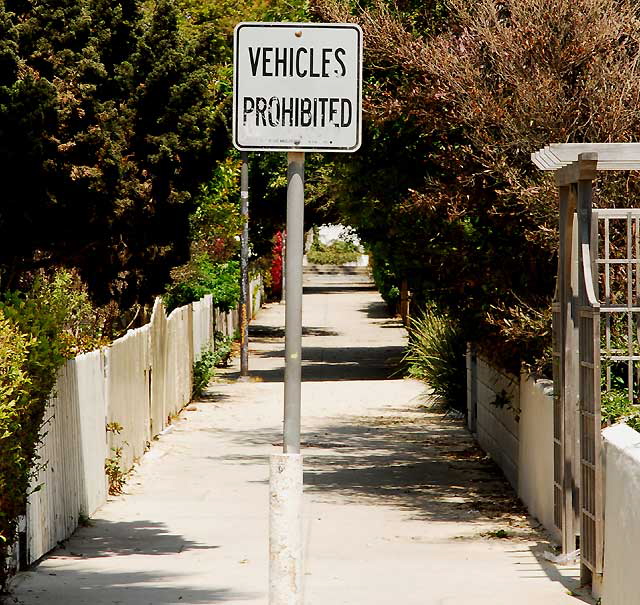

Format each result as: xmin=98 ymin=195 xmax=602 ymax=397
xmin=10 ymin=287 xmax=588 ymax=605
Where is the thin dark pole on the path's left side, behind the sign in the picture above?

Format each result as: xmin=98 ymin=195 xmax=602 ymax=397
xmin=240 ymin=151 xmax=251 ymax=377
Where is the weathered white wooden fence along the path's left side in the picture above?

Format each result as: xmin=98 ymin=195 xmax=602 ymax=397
xmin=20 ymin=279 xmax=262 ymax=563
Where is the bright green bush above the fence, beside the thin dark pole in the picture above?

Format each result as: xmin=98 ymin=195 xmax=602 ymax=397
xmin=164 ymin=255 xmax=240 ymax=312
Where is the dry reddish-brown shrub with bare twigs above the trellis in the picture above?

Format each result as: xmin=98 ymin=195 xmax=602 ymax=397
xmin=315 ymin=0 xmax=640 ymax=368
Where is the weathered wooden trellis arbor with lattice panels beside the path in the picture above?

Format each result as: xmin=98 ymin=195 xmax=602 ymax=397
xmin=532 ymin=143 xmax=640 ymax=594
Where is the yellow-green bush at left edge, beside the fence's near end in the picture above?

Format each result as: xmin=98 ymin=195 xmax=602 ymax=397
xmin=0 ymin=270 xmax=101 ymax=588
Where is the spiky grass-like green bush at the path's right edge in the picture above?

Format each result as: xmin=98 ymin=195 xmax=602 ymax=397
xmin=404 ymin=307 xmax=466 ymax=411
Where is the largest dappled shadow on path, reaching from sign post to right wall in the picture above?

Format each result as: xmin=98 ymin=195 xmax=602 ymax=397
xmin=212 ymin=411 xmax=525 ymax=522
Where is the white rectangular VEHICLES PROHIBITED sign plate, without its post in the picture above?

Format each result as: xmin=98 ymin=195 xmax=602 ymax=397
xmin=233 ymin=23 xmax=362 ymax=152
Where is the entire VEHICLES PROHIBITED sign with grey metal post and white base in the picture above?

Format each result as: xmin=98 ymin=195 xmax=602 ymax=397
xmin=233 ymin=23 xmax=362 ymax=605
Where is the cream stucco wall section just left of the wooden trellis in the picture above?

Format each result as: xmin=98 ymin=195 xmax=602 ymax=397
xmin=518 ymin=375 xmax=560 ymax=541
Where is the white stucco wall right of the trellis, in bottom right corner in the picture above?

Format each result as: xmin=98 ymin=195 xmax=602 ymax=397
xmin=602 ymin=424 xmax=640 ymax=605
